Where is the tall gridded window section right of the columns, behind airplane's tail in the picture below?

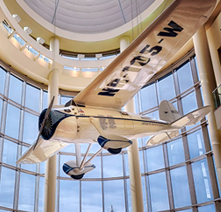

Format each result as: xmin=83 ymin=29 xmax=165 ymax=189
xmin=137 ymin=51 xmax=219 ymax=212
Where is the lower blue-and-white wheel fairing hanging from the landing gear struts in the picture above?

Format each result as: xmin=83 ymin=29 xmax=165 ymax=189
xmin=63 ymin=160 xmax=95 ymax=180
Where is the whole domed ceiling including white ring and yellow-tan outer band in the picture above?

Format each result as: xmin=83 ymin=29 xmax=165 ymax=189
xmin=1 ymin=0 xmax=174 ymax=54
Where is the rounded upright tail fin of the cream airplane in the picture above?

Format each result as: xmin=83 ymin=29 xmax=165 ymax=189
xmin=159 ymin=100 xmax=180 ymax=122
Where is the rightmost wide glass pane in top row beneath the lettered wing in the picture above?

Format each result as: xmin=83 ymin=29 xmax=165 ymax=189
xmin=177 ymin=62 xmax=193 ymax=93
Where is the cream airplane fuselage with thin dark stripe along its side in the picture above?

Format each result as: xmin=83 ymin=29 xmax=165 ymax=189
xmin=48 ymin=106 xmax=177 ymax=143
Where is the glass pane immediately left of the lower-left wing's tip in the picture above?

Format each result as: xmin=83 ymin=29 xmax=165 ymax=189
xmin=2 ymin=140 xmax=17 ymax=166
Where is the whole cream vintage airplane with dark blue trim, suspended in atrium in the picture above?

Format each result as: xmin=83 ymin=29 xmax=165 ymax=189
xmin=17 ymin=0 xmax=216 ymax=179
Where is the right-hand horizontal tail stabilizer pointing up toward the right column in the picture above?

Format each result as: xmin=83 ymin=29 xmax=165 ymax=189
xmin=171 ymin=106 xmax=211 ymax=127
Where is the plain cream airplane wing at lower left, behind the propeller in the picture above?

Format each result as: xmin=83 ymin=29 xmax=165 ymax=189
xmin=17 ymin=137 xmax=69 ymax=164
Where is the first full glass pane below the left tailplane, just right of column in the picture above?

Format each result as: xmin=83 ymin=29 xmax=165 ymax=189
xmin=145 ymin=145 xmax=165 ymax=172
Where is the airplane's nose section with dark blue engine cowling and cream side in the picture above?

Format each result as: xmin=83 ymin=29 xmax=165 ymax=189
xmin=38 ymin=109 xmax=77 ymax=143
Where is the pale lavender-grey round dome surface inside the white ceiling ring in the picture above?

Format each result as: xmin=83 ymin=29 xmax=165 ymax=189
xmin=24 ymin=0 xmax=154 ymax=33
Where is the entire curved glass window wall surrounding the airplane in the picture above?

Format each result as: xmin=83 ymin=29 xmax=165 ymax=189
xmin=0 ymin=50 xmax=220 ymax=212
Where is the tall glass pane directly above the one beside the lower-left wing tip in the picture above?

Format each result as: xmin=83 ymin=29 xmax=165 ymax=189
xmin=5 ymin=104 xmax=20 ymax=139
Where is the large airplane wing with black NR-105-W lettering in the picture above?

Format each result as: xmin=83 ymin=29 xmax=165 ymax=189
xmin=74 ymin=0 xmax=216 ymax=109
